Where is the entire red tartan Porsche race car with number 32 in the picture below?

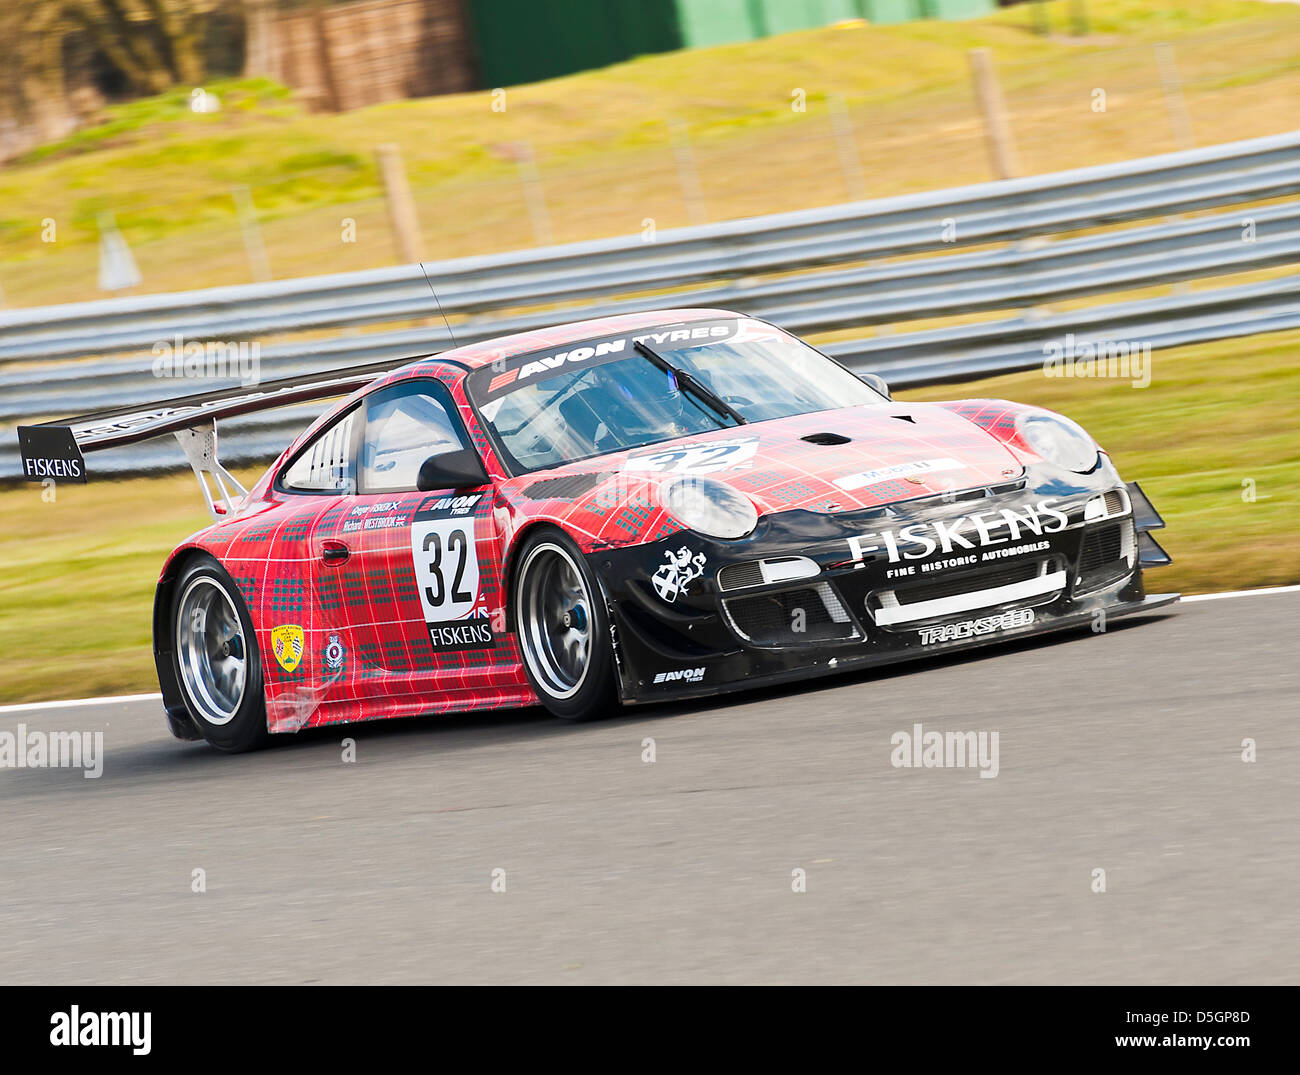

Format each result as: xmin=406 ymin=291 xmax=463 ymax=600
xmin=20 ymin=309 xmax=1178 ymax=750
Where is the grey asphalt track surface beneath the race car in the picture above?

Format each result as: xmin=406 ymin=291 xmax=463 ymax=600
xmin=0 ymin=593 xmax=1300 ymax=984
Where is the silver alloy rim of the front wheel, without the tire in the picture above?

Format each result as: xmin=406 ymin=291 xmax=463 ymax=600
xmin=515 ymin=542 xmax=592 ymax=701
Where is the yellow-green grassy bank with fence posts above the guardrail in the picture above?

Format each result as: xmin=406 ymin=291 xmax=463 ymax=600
xmin=0 ymin=0 xmax=1300 ymax=305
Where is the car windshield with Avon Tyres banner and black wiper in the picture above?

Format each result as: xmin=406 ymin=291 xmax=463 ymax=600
xmin=468 ymin=318 xmax=884 ymax=474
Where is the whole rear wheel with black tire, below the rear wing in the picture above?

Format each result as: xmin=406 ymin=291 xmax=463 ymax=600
xmin=170 ymin=555 xmax=270 ymax=754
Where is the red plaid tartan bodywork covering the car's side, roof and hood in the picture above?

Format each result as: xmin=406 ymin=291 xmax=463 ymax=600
xmin=164 ymin=309 xmax=1076 ymax=731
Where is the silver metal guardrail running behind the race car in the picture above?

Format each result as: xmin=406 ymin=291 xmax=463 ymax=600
xmin=0 ymin=131 xmax=1300 ymax=478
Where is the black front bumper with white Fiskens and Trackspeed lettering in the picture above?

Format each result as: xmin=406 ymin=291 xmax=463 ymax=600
xmin=590 ymin=471 xmax=1178 ymax=703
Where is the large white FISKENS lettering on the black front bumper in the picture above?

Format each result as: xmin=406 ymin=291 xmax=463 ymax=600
xmin=845 ymin=500 xmax=1070 ymax=575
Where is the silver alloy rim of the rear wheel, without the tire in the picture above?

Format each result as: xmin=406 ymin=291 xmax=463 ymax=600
xmin=176 ymin=575 xmax=248 ymax=727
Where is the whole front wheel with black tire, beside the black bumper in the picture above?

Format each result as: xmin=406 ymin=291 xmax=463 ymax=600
xmin=510 ymin=526 xmax=618 ymax=720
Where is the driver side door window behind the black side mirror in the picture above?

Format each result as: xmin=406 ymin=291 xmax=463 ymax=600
xmin=359 ymin=381 xmax=472 ymax=493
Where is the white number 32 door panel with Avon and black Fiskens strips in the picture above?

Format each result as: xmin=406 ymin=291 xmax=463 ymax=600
xmin=411 ymin=493 xmax=495 ymax=651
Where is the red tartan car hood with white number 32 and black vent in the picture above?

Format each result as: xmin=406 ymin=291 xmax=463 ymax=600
xmin=510 ymin=402 xmax=1023 ymax=512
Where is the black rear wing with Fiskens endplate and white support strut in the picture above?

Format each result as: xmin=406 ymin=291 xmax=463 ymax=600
xmin=18 ymin=359 xmax=411 ymax=517
